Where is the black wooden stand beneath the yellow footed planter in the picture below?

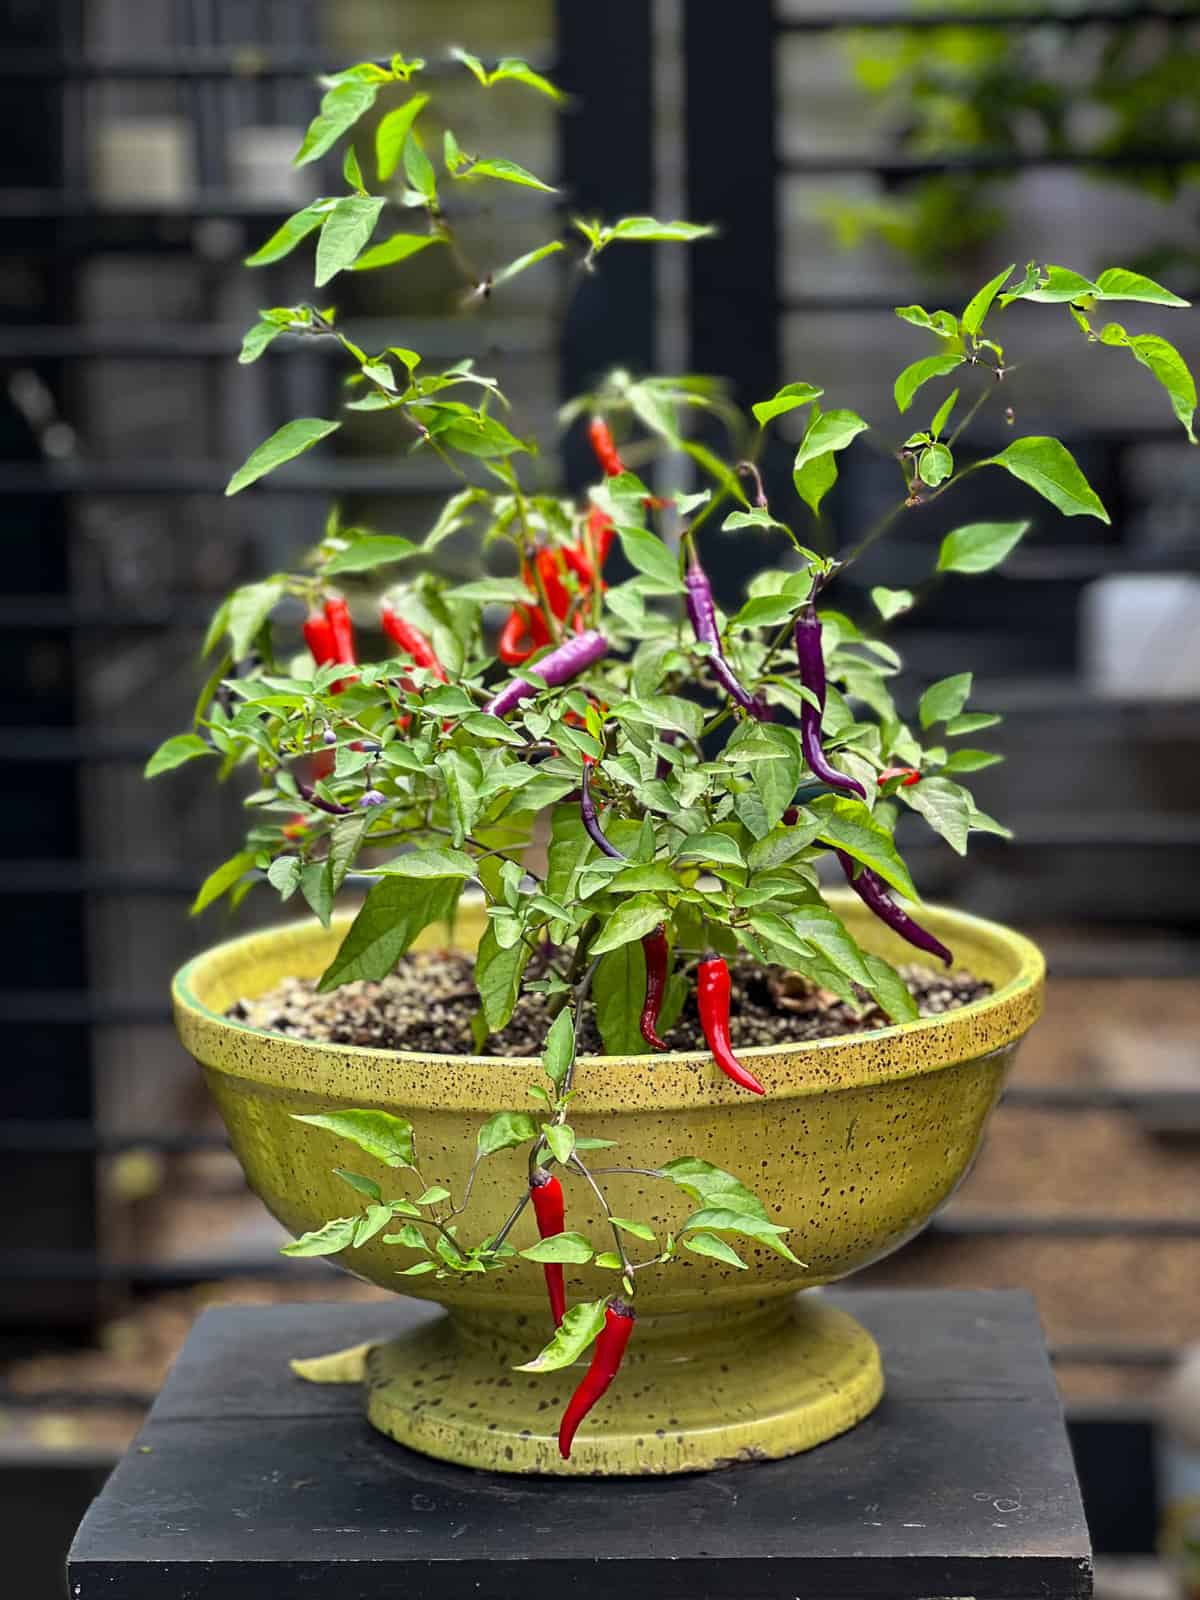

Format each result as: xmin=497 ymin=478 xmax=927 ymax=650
xmin=67 ymin=1291 xmax=1091 ymax=1600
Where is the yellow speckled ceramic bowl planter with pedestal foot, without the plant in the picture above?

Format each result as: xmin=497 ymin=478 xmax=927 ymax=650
xmin=173 ymin=893 xmax=1043 ymax=1474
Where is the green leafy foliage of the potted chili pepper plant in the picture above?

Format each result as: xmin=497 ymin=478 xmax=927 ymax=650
xmin=160 ymin=51 xmax=1195 ymax=1344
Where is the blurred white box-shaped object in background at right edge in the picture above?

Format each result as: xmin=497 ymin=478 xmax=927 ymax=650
xmin=1080 ymin=573 xmax=1200 ymax=699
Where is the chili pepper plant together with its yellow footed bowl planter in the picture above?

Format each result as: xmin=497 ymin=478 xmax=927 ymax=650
xmin=157 ymin=53 xmax=1195 ymax=1474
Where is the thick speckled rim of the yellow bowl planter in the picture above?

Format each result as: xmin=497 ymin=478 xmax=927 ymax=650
xmin=171 ymin=891 xmax=1045 ymax=1114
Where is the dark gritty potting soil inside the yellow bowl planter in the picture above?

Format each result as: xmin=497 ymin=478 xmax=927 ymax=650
xmin=226 ymin=950 xmax=992 ymax=1056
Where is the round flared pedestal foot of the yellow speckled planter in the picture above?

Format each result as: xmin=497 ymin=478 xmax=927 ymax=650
xmin=366 ymin=1291 xmax=883 ymax=1475
